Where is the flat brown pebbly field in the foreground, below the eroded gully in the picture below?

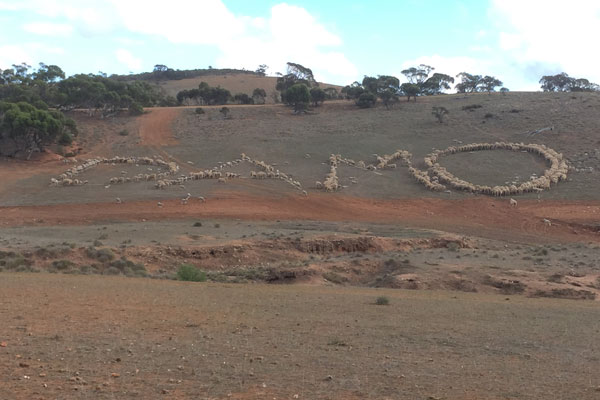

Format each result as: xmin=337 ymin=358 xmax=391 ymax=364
xmin=0 ymin=274 xmax=600 ymax=400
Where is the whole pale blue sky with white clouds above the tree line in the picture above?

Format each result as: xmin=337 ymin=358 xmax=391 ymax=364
xmin=0 ymin=0 xmax=600 ymax=90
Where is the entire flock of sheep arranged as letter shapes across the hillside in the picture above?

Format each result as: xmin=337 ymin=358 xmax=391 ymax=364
xmin=50 ymin=142 xmax=569 ymax=196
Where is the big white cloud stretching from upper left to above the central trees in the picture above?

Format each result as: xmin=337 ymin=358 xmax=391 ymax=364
xmin=0 ymin=0 xmax=358 ymax=82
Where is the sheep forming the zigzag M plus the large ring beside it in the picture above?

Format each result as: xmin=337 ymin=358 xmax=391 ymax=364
xmin=315 ymin=142 xmax=569 ymax=196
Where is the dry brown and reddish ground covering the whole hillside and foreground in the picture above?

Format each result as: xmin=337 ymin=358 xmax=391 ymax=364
xmin=0 ymin=75 xmax=600 ymax=400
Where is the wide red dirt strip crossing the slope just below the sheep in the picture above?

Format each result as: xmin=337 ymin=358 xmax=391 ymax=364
xmin=0 ymin=192 xmax=600 ymax=242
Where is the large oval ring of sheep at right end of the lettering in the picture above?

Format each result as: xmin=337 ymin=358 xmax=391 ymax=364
xmin=424 ymin=142 xmax=569 ymax=196
